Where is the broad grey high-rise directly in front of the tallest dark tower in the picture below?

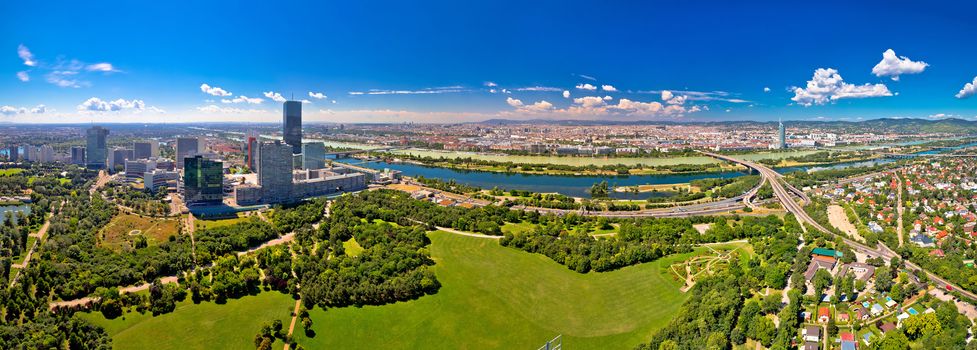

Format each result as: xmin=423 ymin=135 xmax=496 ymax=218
xmin=258 ymin=141 xmax=292 ymax=203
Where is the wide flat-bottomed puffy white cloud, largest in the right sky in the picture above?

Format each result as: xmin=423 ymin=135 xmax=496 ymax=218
xmin=791 ymin=68 xmax=892 ymax=106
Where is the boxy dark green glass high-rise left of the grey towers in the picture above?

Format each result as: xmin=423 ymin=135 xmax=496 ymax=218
xmin=183 ymin=156 xmax=224 ymax=205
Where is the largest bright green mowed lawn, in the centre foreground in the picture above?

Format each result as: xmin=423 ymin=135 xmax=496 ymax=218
xmin=295 ymin=232 xmax=691 ymax=349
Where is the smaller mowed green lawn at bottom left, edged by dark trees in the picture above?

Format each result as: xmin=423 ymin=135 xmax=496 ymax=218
xmin=79 ymin=292 xmax=295 ymax=350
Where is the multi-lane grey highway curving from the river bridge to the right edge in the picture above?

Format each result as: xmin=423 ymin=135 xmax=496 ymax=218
xmin=702 ymin=152 xmax=977 ymax=300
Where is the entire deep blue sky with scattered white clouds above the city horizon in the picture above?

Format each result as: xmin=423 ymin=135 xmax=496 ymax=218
xmin=0 ymin=1 xmax=977 ymax=122
